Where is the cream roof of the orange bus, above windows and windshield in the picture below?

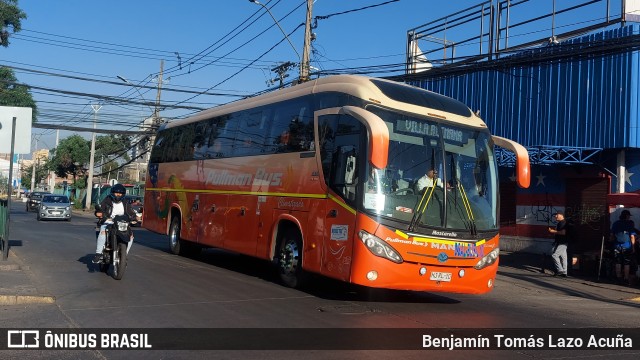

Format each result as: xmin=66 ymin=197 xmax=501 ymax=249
xmin=165 ymin=75 xmax=486 ymax=128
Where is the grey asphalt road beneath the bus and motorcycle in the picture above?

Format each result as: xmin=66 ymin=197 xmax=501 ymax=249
xmin=0 ymin=203 xmax=640 ymax=359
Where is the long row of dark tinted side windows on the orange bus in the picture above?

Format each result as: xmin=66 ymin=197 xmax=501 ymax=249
xmin=150 ymin=96 xmax=318 ymax=163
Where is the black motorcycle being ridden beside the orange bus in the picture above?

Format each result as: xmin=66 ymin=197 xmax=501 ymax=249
xmin=94 ymin=210 xmax=136 ymax=280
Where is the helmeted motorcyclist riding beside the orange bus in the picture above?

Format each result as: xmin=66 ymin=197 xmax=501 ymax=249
xmin=93 ymin=184 xmax=137 ymax=263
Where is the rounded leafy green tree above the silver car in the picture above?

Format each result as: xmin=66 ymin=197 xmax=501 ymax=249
xmin=49 ymin=135 xmax=91 ymax=185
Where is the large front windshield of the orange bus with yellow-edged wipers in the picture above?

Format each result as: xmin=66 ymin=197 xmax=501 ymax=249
xmin=362 ymin=107 xmax=498 ymax=235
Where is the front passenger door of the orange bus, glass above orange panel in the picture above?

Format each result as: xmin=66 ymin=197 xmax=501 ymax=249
xmin=316 ymin=109 xmax=367 ymax=281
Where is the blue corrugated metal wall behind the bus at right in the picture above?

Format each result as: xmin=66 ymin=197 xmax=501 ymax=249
xmin=413 ymin=25 xmax=640 ymax=149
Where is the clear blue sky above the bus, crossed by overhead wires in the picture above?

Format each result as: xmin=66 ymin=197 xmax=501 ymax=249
xmin=0 ymin=0 xmax=619 ymax=158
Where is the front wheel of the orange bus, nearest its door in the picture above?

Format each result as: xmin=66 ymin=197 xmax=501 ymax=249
xmin=277 ymin=229 xmax=304 ymax=288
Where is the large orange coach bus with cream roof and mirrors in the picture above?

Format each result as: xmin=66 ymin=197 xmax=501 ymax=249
xmin=143 ymin=75 xmax=529 ymax=293
